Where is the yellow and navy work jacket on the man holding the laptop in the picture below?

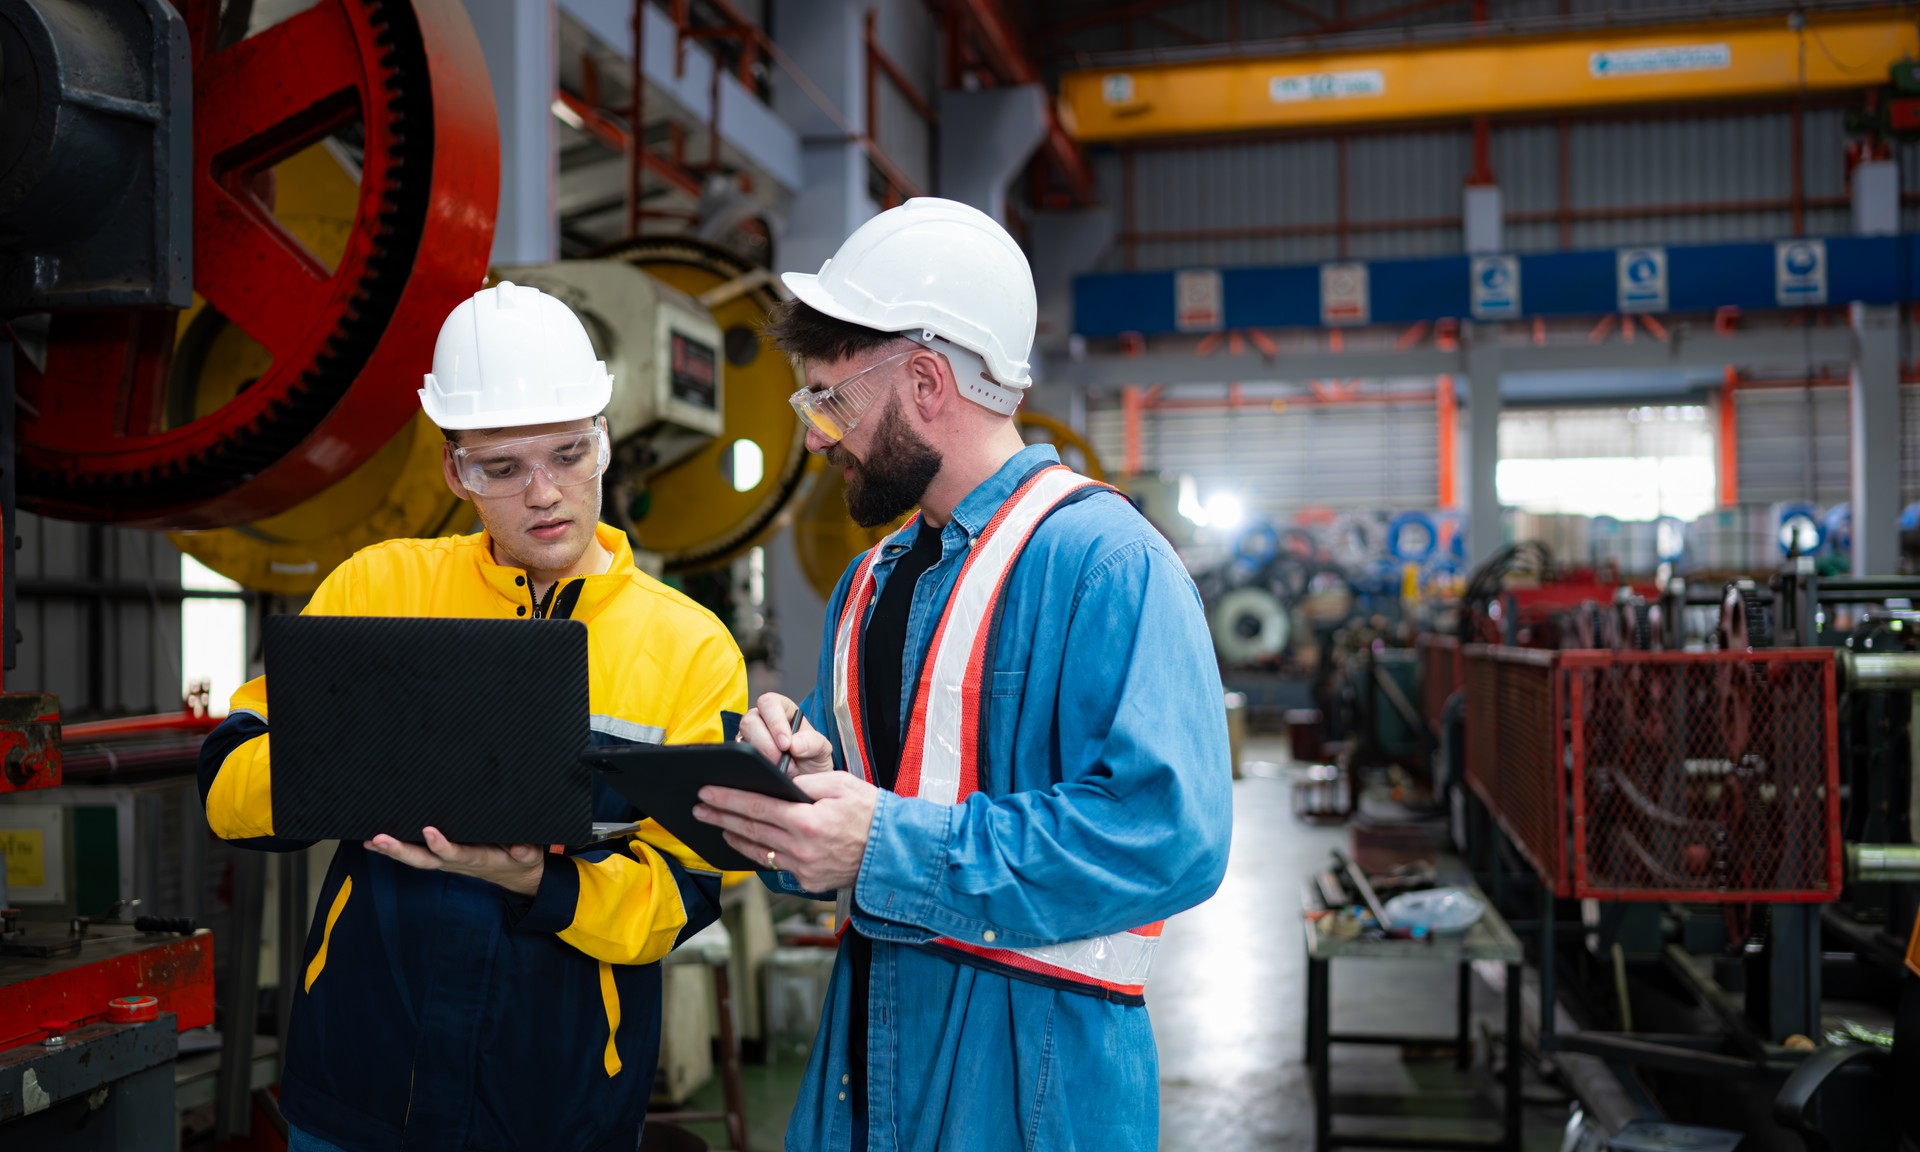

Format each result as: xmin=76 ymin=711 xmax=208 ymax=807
xmin=200 ymin=526 xmax=747 ymax=1152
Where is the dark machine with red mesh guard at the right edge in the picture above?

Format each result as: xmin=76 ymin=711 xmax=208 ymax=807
xmin=1421 ymin=545 xmax=1920 ymax=1148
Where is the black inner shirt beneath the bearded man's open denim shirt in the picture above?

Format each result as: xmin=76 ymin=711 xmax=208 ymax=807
xmin=847 ymin=524 xmax=941 ymax=1150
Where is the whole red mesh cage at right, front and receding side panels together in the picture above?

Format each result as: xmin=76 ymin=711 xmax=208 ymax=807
xmin=1463 ymin=645 xmax=1841 ymax=904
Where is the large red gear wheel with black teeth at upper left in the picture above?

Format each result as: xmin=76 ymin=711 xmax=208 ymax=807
xmin=17 ymin=0 xmax=499 ymax=530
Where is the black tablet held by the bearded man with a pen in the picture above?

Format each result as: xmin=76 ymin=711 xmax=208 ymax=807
xmin=580 ymin=743 xmax=814 ymax=872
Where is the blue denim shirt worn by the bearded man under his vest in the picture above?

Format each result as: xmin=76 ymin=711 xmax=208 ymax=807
xmin=776 ymin=445 xmax=1233 ymax=1152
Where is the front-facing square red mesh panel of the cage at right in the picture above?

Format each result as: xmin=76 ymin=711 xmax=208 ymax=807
xmin=1559 ymin=649 xmax=1841 ymax=902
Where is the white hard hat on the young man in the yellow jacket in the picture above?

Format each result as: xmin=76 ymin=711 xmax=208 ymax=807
xmin=420 ymin=280 xmax=612 ymax=428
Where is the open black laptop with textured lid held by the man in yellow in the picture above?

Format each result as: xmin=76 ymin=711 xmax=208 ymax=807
xmin=265 ymin=616 xmax=593 ymax=845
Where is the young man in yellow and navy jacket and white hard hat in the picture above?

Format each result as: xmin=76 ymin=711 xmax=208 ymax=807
xmin=200 ymin=284 xmax=747 ymax=1152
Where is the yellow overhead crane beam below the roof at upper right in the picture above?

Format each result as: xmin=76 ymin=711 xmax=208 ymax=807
xmin=1060 ymin=10 xmax=1920 ymax=142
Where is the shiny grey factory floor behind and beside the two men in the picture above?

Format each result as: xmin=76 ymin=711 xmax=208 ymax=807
xmin=687 ymin=737 xmax=1569 ymax=1152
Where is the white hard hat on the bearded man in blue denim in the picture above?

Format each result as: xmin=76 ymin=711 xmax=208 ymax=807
xmin=780 ymin=196 xmax=1039 ymax=413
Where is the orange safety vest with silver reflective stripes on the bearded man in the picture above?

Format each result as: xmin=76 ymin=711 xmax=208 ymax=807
xmin=833 ymin=465 xmax=1162 ymax=996
